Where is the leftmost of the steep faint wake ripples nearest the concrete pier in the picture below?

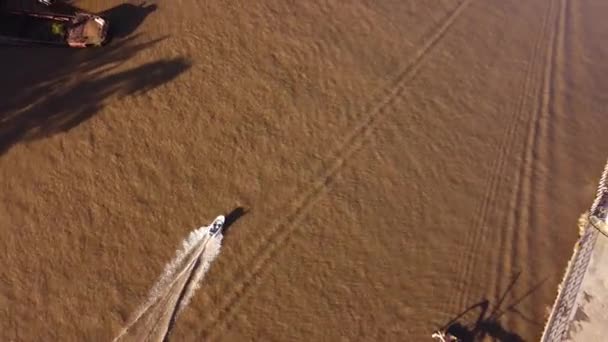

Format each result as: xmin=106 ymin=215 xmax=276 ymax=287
xmin=450 ymin=0 xmax=551 ymax=309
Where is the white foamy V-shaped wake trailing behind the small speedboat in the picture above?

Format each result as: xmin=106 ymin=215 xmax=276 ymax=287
xmin=114 ymin=220 xmax=223 ymax=341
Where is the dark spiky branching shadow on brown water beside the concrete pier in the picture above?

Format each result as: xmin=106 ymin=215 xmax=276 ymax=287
xmin=440 ymin=273 xmax=547 ymax=342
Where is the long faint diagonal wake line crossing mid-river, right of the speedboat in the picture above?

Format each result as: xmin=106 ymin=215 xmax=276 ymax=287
xmin=195 ymin=0 xmax=473 ymax=340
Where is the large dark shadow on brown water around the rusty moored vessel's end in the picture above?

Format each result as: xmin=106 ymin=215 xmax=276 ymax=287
xmin=0 ymin=3 xmax=190 ymax=155
